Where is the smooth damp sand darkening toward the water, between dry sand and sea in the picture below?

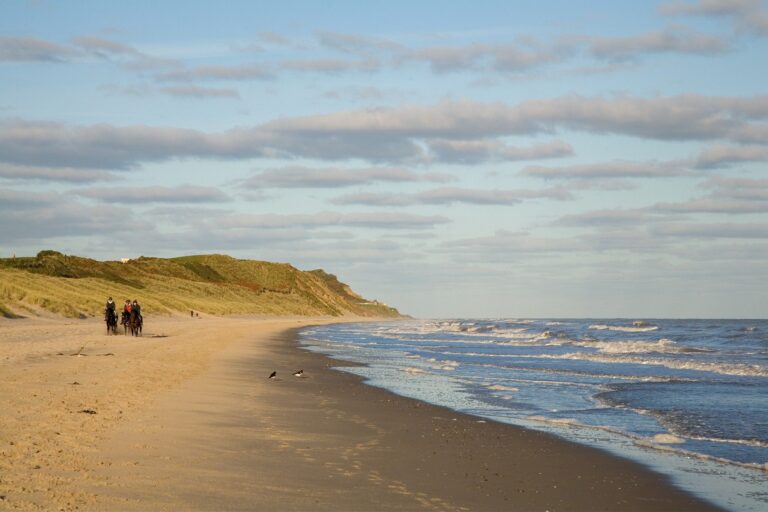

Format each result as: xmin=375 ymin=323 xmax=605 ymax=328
xmin=93 ymin=324 xmax=719 ymax=511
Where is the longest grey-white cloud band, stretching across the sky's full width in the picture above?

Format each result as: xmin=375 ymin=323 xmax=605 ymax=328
xmin=0 ymin=95 xmax=768 ymax=170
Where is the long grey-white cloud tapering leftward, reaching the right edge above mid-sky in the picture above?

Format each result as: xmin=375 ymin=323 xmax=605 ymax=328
xmin=263 ymin=94 xmax=768 ymax=140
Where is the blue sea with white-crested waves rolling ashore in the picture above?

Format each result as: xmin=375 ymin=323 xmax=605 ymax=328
xmin=300 ymin=319 xmax=768 ymax=511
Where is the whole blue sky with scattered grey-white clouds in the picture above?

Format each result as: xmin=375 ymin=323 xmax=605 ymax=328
xmin=0 ymin=0 xmax=768 ymax=318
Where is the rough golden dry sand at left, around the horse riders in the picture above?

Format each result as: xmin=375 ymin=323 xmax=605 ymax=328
xmin=0 ymin=317 xmax=340 ymax=510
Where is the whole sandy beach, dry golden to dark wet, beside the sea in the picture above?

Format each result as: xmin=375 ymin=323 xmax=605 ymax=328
xmin=0 ymin=317 xmax=715 ymax=511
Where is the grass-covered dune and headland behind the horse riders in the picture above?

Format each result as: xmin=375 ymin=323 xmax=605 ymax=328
xmin=0 ymin=251 xmax=399 ymax=317
